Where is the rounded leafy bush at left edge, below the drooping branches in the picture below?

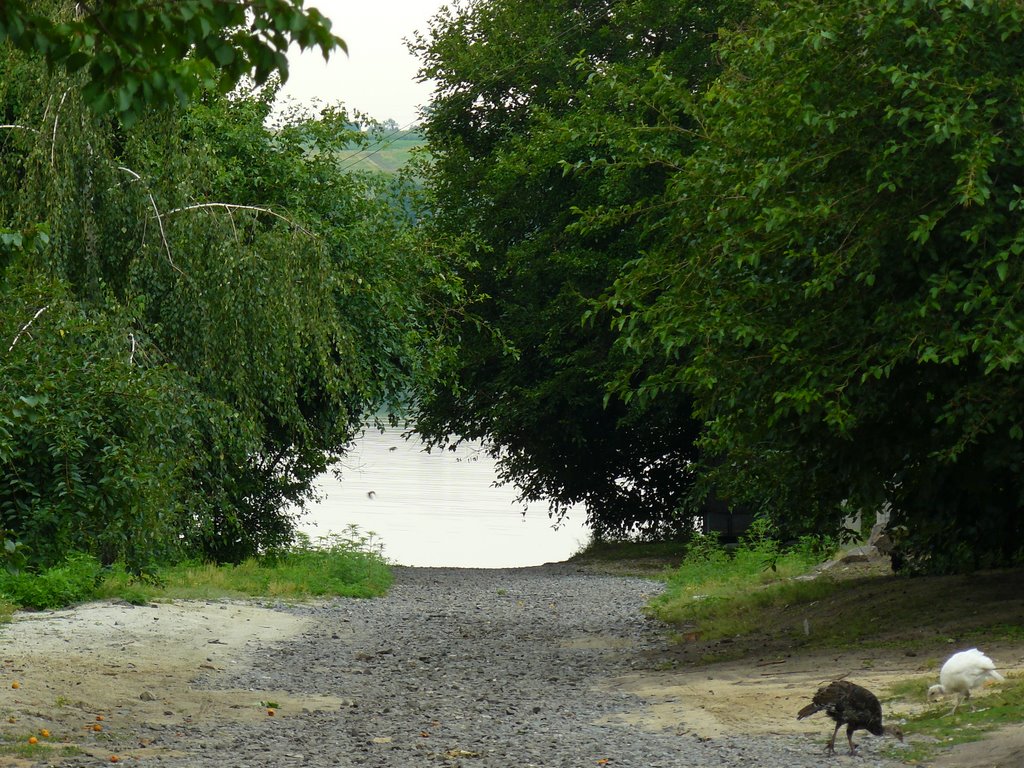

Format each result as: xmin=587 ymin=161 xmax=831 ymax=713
xmin=0 ymin=274 xmax=190 ymax=570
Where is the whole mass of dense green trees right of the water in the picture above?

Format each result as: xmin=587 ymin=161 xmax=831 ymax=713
xmin=418 ymin=0 xmax=1024 ymax=570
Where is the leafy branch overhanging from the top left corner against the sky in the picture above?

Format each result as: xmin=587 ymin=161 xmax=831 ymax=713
xmin=0 ymin=0 xmax=345 ymax=122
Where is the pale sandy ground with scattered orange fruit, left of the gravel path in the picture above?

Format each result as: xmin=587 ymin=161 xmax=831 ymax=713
xmin=0 ymin=601 xmax=339 ymax=766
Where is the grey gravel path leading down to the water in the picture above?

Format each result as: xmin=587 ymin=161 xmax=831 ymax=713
xmin=96 ymin=564 xmax=898 ymax=768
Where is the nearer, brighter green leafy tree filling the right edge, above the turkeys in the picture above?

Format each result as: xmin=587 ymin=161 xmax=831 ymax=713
xmin=607 ymin=0 xmax=1024 ymax=570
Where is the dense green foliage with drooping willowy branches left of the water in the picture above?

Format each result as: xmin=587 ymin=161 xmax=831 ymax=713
xmin=0 ymin=1 xmax=457 ymax=570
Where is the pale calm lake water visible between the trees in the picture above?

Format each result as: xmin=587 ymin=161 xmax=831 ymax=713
xmin=298 ymin=429 xmax=590 ymax=568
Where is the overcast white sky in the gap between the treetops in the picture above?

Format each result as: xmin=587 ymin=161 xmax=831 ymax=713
xmin=282 ymin=0 xmax=447 ymax=127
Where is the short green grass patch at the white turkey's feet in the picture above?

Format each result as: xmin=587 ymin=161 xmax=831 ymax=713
xmin=887 ymin=675 xmax=1024 ymax=762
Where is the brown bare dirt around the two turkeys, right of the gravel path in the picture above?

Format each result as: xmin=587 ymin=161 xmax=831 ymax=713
xmin=609 ymin=558 xmax=1024 ymax=768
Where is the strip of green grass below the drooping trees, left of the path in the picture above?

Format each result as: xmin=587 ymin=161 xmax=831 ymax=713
xmin=0 ymin=527 xmax=392 ymax=622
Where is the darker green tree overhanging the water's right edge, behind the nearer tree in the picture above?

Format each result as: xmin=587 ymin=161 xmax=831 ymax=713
xmin=414 ymin=0 xmax=743 ymax=536
